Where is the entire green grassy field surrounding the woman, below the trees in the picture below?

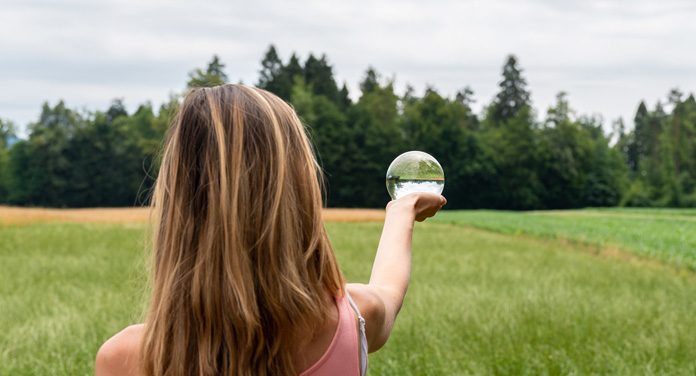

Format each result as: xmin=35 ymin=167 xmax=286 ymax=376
xmin=0 ymin=210 xmax=696 ymax=375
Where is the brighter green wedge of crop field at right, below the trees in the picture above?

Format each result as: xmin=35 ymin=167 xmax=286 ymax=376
xmin=436 ymin=209 xmax=696 ymax=271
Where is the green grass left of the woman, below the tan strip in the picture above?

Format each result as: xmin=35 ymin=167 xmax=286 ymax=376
xmin=0 ymin=224 xmax=145 ymax=376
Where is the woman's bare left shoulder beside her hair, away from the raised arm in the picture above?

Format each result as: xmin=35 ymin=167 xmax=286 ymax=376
xmin=94 ymin=324 xmax=144 ymax=376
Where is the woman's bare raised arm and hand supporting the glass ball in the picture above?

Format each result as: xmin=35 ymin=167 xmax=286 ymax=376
xmin=347 ymin=193 xmax=447 ymax=352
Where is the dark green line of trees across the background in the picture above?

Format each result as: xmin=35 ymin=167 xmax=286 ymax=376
xmin=0 ymin=46 xmax=696 ymax=210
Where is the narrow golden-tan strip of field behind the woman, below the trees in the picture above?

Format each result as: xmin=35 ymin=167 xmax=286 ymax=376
xmin=0 ymin=206 xmax=384 ymax=224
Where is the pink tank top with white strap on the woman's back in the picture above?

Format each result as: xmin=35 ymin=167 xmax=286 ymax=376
xmin=300 ymin=296 xmax=360 ymax=376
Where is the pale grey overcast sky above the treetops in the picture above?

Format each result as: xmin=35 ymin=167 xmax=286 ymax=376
xmin=0 ymin=0 xmax=696 ymax=135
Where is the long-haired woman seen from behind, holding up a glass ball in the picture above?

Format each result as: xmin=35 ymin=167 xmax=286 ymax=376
xmin=96 ymin=85 xmax=446 ymax=376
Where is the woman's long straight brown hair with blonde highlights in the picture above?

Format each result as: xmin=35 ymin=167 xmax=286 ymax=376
xmin=141 ymin=85 xmax=344 ymax=376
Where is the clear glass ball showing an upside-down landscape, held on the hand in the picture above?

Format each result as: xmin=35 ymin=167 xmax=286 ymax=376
xmin=387 ymin=151 xmax=445 ymax=200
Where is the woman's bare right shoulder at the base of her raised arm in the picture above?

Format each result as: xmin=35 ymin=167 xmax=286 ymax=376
xmin=346 ymin=283 xmax=389 ymax=352
